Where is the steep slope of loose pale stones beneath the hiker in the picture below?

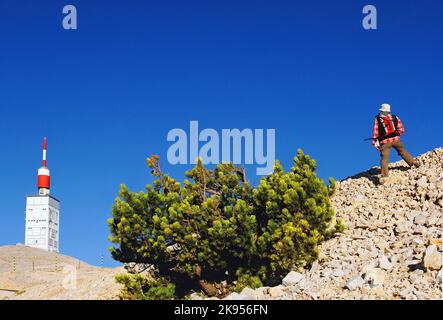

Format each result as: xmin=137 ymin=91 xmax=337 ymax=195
xmin=198 ymin=148 xmax=443 ymax=299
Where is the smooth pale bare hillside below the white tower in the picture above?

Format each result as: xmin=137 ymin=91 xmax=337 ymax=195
xmin=0 ymin=245 xmax=123 ymax=304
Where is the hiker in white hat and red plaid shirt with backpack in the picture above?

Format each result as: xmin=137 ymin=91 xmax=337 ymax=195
xmin=372 ymin=103 xmax=420 ymax=184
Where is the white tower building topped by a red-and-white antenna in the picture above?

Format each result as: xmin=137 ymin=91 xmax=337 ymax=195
xmin=25 ymin=138 xmax=60 ymax=252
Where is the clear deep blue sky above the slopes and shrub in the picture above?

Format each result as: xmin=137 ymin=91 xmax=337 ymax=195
xmin=0 ymin=0 xmax=443 ymax=265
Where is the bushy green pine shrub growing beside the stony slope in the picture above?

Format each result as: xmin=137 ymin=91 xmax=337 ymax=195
xmin=108 ymin=150 xmax=343 ymax=299
